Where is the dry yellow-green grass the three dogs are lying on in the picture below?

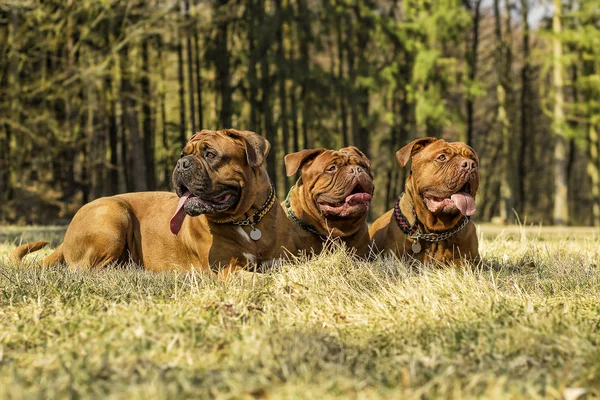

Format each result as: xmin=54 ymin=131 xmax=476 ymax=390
xmin=0 ymin=228 xmax=600 ymax=399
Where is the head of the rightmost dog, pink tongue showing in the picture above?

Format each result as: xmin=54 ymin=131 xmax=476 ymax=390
xmin=396 ymin=138 xmax=479 ymax=216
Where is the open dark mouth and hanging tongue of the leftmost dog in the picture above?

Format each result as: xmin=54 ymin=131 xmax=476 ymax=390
xmin=170 ymin=186 xmax=239 ymax=235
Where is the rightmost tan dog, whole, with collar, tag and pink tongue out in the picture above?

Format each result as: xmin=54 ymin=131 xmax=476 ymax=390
xmin=369 ymin=138 xmax=479 ymax=265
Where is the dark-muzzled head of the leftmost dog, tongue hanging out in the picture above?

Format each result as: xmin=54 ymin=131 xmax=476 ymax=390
xmin=171 ymin=129 xmax=271 ymax=234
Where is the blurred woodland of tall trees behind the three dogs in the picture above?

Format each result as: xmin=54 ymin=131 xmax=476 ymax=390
xmin=0 ymin=0 xmax=600 ymax=226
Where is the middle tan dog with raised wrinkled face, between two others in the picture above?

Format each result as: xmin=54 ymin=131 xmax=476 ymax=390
xmin=283 ymin=146 xmax=374 ymax=256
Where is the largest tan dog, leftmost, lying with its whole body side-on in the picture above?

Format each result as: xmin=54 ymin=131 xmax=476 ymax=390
xmin=11 ymin=129 xmax=294 ymax=273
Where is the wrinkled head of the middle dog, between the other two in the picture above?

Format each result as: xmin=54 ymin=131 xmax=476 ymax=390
xmin=285 ymin=146 xmax=374 ymax=236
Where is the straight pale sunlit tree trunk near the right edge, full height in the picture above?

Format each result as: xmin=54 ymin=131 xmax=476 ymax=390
xmin=552 ymin=0 xmax=569 ymax=226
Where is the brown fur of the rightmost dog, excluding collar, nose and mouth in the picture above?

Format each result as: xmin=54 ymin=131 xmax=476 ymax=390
xmin=369 ymin=138 xmax=479 ymax=264
